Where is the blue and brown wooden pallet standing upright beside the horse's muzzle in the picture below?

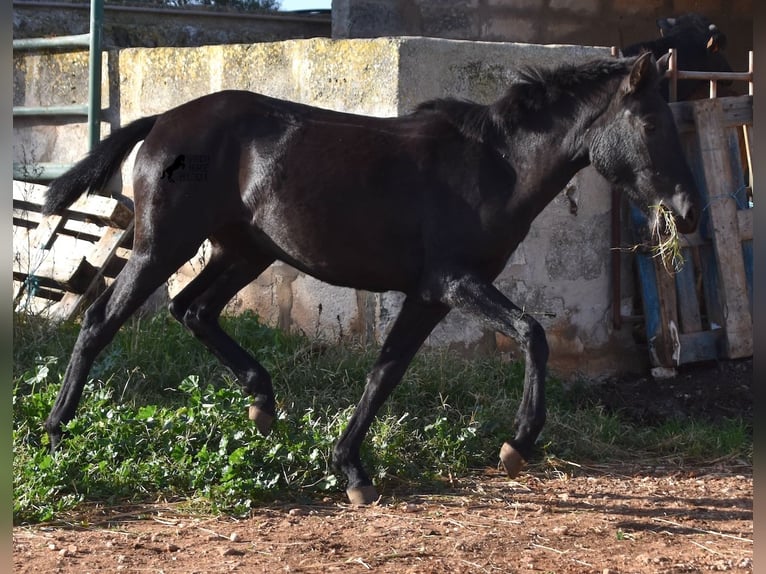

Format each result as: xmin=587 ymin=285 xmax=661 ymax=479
xmin=631 ymin=96 xmax=753 ymax=368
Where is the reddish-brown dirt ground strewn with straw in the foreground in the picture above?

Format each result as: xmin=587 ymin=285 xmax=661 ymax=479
xmin=13 ymin=361 xmax=753 ymax=574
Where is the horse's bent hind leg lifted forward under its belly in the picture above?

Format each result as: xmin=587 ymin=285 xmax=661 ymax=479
xmin=170 ymin=246 xmax=276 ymax=435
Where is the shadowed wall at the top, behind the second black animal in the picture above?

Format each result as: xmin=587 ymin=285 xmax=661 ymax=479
xmin=332 ymin=0 xmax=753 ymax=83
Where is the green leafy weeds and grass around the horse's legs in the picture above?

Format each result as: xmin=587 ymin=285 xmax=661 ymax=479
xmin=13 ymin=313 xmax=752 ymax=523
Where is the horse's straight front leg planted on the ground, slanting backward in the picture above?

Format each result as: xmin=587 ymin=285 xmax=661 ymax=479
xmin=333 ymin=297 xmax=449 ymax=504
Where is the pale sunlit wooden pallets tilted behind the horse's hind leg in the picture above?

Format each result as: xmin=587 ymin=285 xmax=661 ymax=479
xmin=13 ymin=181 xmax=133 ymax=320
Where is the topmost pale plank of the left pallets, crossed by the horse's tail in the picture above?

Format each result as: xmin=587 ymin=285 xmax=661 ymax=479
xmin=13 ymin=181 xmax=133 ymax=229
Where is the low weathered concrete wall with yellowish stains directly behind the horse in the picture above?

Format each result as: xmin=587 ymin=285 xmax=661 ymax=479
xmin=14 ymin=37 xmax=660 ymax=375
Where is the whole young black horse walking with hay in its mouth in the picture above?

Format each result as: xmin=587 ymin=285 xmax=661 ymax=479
xmin=44 ymin=54 xmax=699 ymax=503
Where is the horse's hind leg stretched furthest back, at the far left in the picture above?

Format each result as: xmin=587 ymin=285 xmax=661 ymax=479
xmin=44 ymin=251 xmax=188 ymax=451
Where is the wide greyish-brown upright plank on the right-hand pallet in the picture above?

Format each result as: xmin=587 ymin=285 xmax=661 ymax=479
xmin=693 ymin=100 xmax=753 ymax=358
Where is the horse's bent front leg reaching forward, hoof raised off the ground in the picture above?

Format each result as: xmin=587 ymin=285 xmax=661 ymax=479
xmin=443 ymin=276 xmax=548 ymax=478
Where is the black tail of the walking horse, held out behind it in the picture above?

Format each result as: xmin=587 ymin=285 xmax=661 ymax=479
xmin=43 ymin=116 xmax=159 ymax=215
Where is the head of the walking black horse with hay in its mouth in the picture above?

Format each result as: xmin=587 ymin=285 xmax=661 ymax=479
xmin=589 ymin=53 xmax=700 ymax=233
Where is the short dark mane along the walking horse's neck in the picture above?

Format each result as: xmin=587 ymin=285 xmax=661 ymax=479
xmin=414 ymin=59 xmax=633 ymax=141
